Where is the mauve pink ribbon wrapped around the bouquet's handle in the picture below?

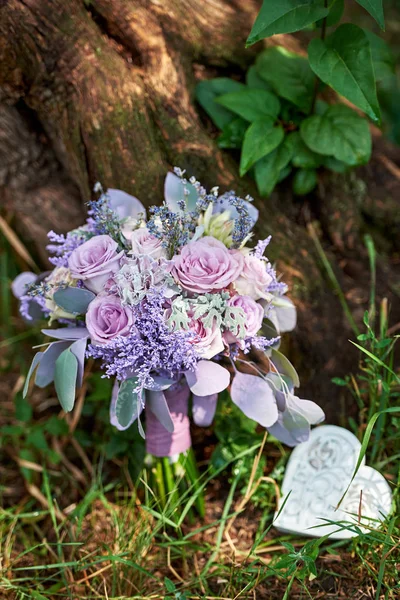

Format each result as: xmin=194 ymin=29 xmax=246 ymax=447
xmin=146 ymin=379 xmax=192 ymax=458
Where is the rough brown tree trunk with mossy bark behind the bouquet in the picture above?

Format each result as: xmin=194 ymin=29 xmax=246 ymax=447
xmin=0 ymin=0 xmax=400 ymax=419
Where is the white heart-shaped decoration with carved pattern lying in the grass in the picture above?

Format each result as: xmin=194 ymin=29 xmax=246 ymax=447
xmin=274 ymin=425 xmax=392 ymax=539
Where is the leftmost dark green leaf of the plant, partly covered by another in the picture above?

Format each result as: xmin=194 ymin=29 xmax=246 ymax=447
xmin=195 ymin=77 xmax=245 ymax=129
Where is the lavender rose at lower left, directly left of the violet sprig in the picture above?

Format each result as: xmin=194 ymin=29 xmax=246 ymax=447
xmin=86 ymin=294 xmax=134 ymax=344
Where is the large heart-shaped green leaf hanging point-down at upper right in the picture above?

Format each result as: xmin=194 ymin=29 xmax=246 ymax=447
xmin=308 ymin=23 xmax=380 ymax=121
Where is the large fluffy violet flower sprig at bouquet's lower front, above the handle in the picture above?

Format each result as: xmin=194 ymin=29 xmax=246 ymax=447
xmin=87 ymin=291 xmax=198 ymax=389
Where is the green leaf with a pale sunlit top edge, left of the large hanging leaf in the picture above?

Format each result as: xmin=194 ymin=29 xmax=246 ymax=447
xmin=256 ymin=46 xmax=315 ymax=113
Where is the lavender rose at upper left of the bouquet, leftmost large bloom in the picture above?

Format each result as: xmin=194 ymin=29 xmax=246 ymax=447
xmin=68 ymin=235 xmax=124 ymax=294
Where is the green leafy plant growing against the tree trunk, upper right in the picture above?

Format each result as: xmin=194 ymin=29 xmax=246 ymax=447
xmin=196 ymin=0 xmax=393 ymax=196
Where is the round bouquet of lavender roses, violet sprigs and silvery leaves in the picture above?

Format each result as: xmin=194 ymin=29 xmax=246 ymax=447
xmin=13 ymin=169 xmax=324 ymax=490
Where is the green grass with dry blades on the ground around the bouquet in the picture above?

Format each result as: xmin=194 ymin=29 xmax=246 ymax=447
xmin=0 ymin=231 xmax=400 ymax=600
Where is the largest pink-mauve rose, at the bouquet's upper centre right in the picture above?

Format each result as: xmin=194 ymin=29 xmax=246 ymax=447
xmin=171 ymin=236 xmax=244 ymax=294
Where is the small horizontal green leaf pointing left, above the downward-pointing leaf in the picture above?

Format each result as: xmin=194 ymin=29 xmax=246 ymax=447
xmin=216 ymin=89 xmax=281 ymax=122
